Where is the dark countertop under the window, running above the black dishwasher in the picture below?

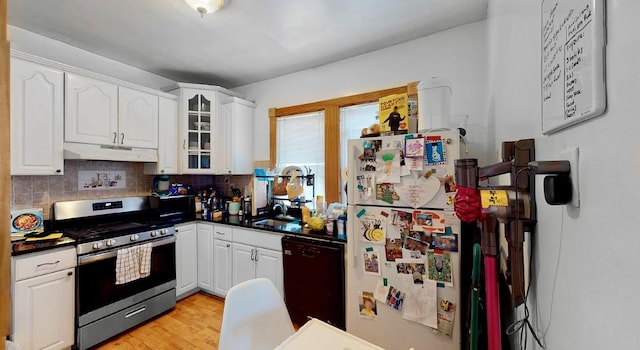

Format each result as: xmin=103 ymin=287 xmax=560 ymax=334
xmin=196 ymin=214 xmax=347 ymax=243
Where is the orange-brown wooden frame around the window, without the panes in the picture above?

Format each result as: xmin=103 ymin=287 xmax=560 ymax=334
xmin=269 ymin=82 xmax=418 ymax=203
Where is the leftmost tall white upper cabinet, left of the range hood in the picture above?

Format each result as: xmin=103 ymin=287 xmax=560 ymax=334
xmin=11 ymin=58 xmax=64 ymax=175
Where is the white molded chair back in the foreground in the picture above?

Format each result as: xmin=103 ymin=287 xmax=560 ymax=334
xmin=218 ymin=278 xmax=295 ymax=350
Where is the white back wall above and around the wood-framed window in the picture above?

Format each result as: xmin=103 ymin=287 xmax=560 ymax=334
xmin=234 ymin=21 xmax=487 ymax=164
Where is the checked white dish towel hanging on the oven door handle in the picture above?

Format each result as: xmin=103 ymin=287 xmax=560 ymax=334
xmin=116 ymin=243 xmax=152 ymax=284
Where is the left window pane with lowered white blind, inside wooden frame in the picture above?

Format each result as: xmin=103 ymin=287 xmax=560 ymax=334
xmin=276 ymin=112 xmax=325 ymax=200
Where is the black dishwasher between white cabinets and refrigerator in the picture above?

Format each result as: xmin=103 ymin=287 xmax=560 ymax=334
xmin=282 ymin=236 xmax=345 ymax=330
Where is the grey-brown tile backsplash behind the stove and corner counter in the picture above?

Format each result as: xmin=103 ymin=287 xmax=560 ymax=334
xmin=11 ymin=160 xmax=251 ymax=219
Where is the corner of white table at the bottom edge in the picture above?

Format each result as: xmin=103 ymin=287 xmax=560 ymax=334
xmin=275 ymin=318 xmax=384 ymax=350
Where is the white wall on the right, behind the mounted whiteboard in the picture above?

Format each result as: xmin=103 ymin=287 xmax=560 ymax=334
xmin=487 ymin=0 xmax=640 ymax=349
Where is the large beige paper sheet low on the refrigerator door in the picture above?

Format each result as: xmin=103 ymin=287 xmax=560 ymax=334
xmin=402 ymin=281 xmax=438 ymax=328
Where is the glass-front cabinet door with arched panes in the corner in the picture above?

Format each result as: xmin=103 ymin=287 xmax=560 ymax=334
xmin=183 ymin=91 xmax=216 ymax=173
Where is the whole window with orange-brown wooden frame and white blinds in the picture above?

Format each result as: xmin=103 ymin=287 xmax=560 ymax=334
xmin=269 ymin=82 xmax=418 ymax=203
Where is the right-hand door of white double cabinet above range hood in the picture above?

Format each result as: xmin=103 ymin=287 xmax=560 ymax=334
xmin=118 ymin=86 xmax=158 ymax=149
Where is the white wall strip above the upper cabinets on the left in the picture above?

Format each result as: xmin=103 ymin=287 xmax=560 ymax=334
xmin=8 ymin=26 xmax=174 ymax=90
